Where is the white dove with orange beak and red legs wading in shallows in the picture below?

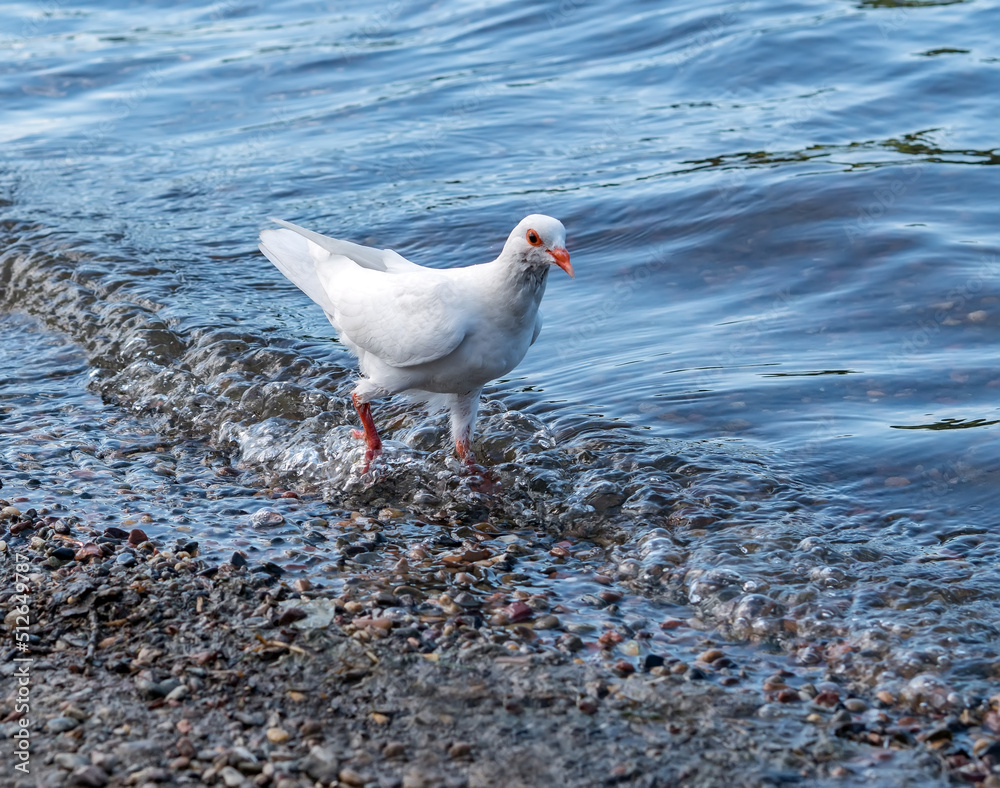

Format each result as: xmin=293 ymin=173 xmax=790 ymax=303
xmin=260 ymin=214 xmax=573 ymax=472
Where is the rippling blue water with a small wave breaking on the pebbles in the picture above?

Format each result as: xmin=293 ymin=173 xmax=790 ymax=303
xmin=0 ymin=0 xmax=1000 ymax=716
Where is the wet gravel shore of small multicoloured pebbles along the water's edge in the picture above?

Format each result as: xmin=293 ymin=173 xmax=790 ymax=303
xmin=0 ymin=480 xmax=1000 ymax=788
